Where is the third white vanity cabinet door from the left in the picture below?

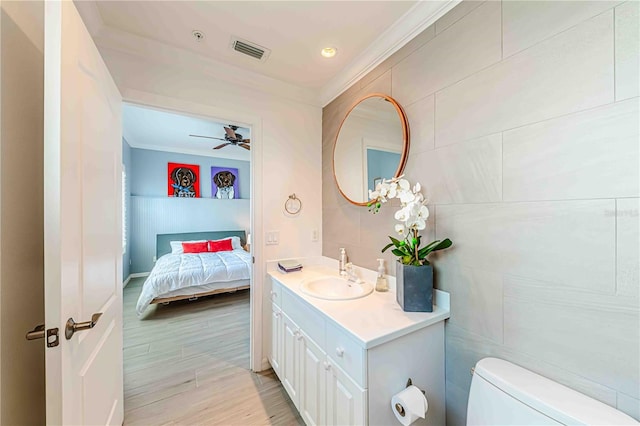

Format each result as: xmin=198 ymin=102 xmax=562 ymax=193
xmin=298 ymin=332 xmax=327 ymax=426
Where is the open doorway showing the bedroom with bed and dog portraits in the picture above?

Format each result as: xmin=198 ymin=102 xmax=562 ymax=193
xmin=122 ymin=103 xmax=292 ymax=424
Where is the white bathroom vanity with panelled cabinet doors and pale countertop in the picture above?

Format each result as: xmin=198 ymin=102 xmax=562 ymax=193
xmin=269 ymin=266 xmax=449 ymax=425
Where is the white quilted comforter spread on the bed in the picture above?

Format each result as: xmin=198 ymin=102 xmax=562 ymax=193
xmin=136 ymin=250 xmax=251 ymax=315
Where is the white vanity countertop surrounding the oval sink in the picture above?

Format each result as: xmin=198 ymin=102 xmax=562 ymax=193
xmin=267 ymin=257 xmax=449 ymax=349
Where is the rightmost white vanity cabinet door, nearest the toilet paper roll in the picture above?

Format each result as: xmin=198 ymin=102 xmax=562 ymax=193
xmin=325 ymin=356 xmax=367 ymax=426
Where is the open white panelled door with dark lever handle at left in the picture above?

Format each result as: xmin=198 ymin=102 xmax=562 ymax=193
xmin=44 ymin=1 xmax=123 ymax=425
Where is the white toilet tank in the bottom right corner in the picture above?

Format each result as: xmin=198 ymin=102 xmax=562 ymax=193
xmin=467 ymin=358 xmax=640 ymax=425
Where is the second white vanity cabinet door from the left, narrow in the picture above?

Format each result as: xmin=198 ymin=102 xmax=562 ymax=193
xmin=280 ymin=313 xmax=300 ymax=408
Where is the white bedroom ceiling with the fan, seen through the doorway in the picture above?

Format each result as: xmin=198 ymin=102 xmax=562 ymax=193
xmin=122 ymin=103 xmax=251 ymax=161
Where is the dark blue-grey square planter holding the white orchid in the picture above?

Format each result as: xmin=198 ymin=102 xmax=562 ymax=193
xmin=396 ymin=262 xmax=433 ymax=312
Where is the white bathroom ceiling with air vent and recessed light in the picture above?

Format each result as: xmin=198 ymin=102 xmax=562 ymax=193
xmin=76 ymin=0 xmax=459 ymax=106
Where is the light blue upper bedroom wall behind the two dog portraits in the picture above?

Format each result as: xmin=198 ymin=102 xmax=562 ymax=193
xmin=131 ymin=148 xmax=251 ymax=199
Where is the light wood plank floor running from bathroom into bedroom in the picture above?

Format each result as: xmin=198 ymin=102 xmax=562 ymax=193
xmin=124 ymin=278 xmax=304 ymax=425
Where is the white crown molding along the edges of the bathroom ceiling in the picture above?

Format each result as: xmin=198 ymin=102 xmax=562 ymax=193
xmin=75 ymin=0 xmax=462 ymax=107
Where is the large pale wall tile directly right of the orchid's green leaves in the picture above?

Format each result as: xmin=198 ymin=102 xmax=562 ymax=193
xmin=436 ymin=200 xmax=615 ymax=294
